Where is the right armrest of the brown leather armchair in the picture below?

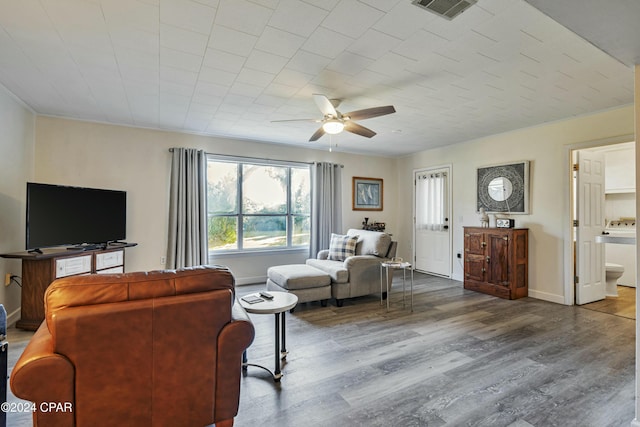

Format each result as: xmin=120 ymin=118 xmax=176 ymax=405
xmin=214 ymin=301 xmax=255 ymax=422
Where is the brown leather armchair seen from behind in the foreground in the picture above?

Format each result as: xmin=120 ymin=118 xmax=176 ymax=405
xmin=11 ymin=266 xmax=254 ymax=427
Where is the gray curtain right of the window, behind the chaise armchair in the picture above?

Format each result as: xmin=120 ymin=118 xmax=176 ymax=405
xmin=309 ymin=163 xmax=342 ymax=258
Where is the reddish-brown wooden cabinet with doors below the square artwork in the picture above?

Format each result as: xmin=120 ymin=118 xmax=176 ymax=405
xmin=464 ymin=227 xmax=529 ymax=299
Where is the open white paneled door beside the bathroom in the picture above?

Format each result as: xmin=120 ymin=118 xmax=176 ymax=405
xmin=575 ymin=150 xmax=606 ymax=305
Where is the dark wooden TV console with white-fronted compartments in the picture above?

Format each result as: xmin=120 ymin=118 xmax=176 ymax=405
xmin=0 ymin=243 xmax=136 ymax=331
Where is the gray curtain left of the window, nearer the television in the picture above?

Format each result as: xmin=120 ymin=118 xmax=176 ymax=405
xmin=167 ymin=148 xmax=208 ymax=268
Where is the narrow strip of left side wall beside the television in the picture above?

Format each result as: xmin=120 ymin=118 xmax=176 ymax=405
xmin=0 ymin=88 xmax=35 ymax=324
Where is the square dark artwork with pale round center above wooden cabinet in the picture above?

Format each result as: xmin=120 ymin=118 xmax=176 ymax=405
xmin=476 ymin=160 xmax=529 ymax=214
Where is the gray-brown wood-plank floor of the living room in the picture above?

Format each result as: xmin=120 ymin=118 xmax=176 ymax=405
xmin=3 ymin=272 xmax=635 ymax=427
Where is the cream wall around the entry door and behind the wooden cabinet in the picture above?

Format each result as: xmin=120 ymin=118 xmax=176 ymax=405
xmin=396 ymin=106 xmax=634 ymax=303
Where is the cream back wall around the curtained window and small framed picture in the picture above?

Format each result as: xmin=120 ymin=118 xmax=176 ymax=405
xmin=34 ymin=117 xmax=397 ymax=284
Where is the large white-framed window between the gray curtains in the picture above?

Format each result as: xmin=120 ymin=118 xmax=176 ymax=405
xmin=207 ymin=155 xmax=311 ymax=252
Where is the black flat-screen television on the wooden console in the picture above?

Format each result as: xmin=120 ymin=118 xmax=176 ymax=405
xmin=26 ymin=182 xmax=127 ymax=250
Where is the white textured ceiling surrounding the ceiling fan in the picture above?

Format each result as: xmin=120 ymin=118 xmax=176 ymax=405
xmin=0 ymin=0 xmax=633 ymax=156
